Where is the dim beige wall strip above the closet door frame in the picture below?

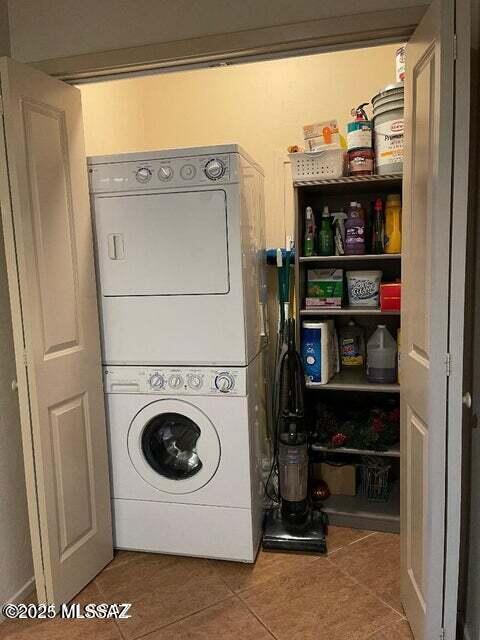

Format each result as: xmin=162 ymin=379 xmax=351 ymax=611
xmin=9 ymin=0 xmax=422 ymax=61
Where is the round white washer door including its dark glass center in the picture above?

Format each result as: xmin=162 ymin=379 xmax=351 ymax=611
xmin=128 ymin=399 xmax=221 ymax=494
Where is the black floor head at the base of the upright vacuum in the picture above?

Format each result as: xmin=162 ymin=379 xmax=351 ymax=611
xmin=262 ymin=507 xmax=327 ymax=553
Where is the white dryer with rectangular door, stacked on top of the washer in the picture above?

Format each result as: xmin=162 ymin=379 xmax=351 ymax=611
xmin=88 ymin=145 xmax=266 ymax=366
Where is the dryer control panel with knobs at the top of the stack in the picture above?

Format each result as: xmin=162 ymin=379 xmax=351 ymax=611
xmin=89 ymin=153 xmax=234 ymax=193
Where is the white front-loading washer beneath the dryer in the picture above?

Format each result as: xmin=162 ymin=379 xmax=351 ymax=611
xmin=104 ymin=356 xmax=266 ymax=562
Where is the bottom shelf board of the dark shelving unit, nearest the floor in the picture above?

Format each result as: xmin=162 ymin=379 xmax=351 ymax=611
xmin=322 ymin=483 xmax=400 ymax=533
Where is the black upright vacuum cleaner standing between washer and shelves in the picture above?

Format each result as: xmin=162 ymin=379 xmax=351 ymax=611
xmin=263 ymin=248 xmax=327 ymax=553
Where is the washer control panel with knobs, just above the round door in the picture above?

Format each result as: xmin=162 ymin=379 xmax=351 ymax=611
xmin=103 ymin=366 xmax=247 ymax=396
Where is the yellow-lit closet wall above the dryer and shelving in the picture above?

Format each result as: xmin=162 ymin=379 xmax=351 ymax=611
xmin=81 ymin=45 xmax=396 ymax=246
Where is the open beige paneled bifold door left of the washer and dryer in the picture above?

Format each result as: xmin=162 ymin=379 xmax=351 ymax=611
xmin=0 ymin=58 xmax=112 ymax=605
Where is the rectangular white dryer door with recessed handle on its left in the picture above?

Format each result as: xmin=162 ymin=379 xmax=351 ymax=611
xmin=94 ymin=190 xmax=229 ymax=296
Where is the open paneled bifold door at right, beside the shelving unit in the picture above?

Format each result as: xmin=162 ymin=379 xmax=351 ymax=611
xmin=401 ymin=0 xmax=469 ymax=640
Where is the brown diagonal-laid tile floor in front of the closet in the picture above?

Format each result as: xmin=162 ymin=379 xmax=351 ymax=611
xmin=0 ymin=527 xmax=413 ymax=640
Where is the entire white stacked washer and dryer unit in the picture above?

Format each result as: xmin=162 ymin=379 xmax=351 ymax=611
xmin=88 ymin=145 xmax=268 ymax=562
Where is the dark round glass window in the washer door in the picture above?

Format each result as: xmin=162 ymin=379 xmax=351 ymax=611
xmin=142 ymin=413 xmax=203 ymax=480
